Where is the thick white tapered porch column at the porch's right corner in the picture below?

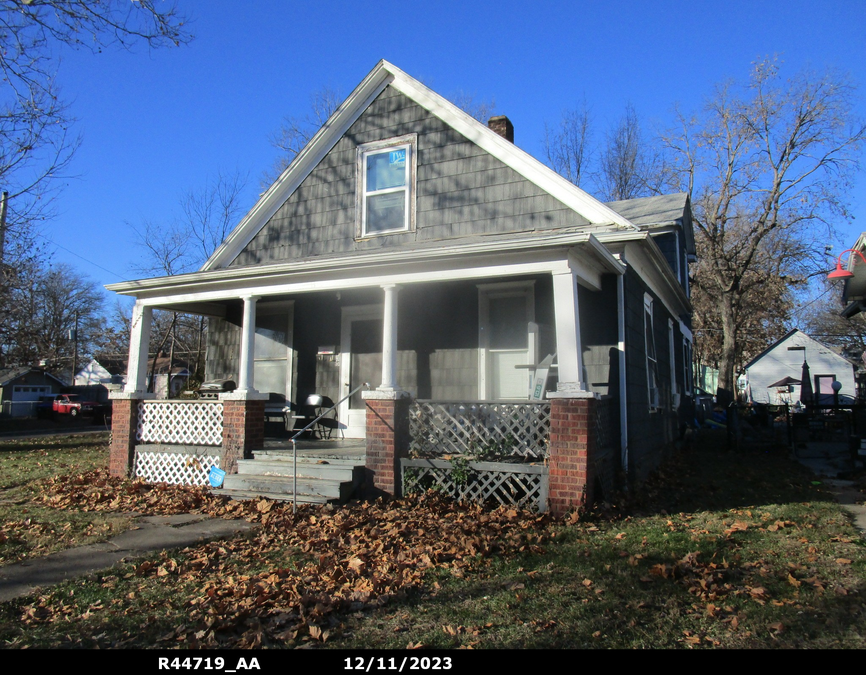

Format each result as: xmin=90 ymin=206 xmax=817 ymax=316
xmin=553 ymin=271 xmax=586 ymax=394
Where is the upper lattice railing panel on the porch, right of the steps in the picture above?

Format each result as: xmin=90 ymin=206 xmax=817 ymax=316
xmin=409 ymin=401 xmax=550 ymax=461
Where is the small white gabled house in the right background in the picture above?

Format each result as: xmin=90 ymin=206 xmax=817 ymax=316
xmin=745 ymin=328 xmax=856 ymax=405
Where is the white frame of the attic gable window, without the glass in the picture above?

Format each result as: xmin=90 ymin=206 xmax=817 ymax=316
xmin=355 ymin=134 xmax=418 ymax=239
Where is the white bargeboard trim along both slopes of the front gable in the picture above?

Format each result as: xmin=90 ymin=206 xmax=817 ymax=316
xmin=200 ymin=60 xmax=639 ymax=272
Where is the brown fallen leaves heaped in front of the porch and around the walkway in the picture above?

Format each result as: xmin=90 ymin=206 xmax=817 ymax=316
xmin=21 ymin=472 xmax=550 ymax=647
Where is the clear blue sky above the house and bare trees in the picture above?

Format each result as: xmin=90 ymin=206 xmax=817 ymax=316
xmin=32 ymin=0 xmax=866 ymax=294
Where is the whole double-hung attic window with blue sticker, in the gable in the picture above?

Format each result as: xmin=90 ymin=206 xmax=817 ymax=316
xmin=357 ymin=134 xmax=417 ymax=238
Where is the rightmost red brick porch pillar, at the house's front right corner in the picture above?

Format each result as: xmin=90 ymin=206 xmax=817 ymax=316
xmin=548 ymin=393 xmax=597 ymax=515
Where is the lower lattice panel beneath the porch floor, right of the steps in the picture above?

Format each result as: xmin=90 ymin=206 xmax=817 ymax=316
xmin=400 ymin=459 xmax=548 ymax=512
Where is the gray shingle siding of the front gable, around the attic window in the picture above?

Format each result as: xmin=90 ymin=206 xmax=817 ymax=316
xmin=231 ymin=87 xmax=588 ymax=266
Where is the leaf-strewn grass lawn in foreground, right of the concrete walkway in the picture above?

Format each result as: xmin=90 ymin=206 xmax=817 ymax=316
xmin=0 ymin=434 xmax=866 ymax=649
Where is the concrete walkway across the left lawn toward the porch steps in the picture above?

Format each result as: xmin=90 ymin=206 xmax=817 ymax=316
xmin=0 ymin=514 xmax=254 ymax=602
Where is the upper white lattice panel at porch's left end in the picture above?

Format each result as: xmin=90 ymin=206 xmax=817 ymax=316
xmin=137 ymin=401 xmax=223 ymax=445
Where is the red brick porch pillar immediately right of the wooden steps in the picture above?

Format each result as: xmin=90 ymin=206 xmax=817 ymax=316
xmin=363 ymin=391 xmax=412 ymax=499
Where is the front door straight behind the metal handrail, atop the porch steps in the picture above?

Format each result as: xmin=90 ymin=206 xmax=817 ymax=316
xmin=339 ymin=305 xmax=383 ymax=438
